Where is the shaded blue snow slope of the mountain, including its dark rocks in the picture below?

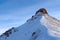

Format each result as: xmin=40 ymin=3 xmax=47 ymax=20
xmin=0 ymin=9 xmax=60 ymax=40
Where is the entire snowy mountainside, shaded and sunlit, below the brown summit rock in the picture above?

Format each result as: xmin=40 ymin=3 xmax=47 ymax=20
xmin=0 ymin=8 xmax=60 ymax=40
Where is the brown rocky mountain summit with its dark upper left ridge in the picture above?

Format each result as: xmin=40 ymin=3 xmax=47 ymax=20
xmin=27 ymin=8 xmax=48 ymax=22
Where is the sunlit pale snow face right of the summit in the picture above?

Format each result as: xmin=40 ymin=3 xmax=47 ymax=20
xmin=41 ymin=15 xmax=60 ymax=38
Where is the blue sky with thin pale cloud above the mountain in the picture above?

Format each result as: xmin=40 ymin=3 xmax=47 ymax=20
xmin=0 ymin=0 xmax=60 ymax=34
